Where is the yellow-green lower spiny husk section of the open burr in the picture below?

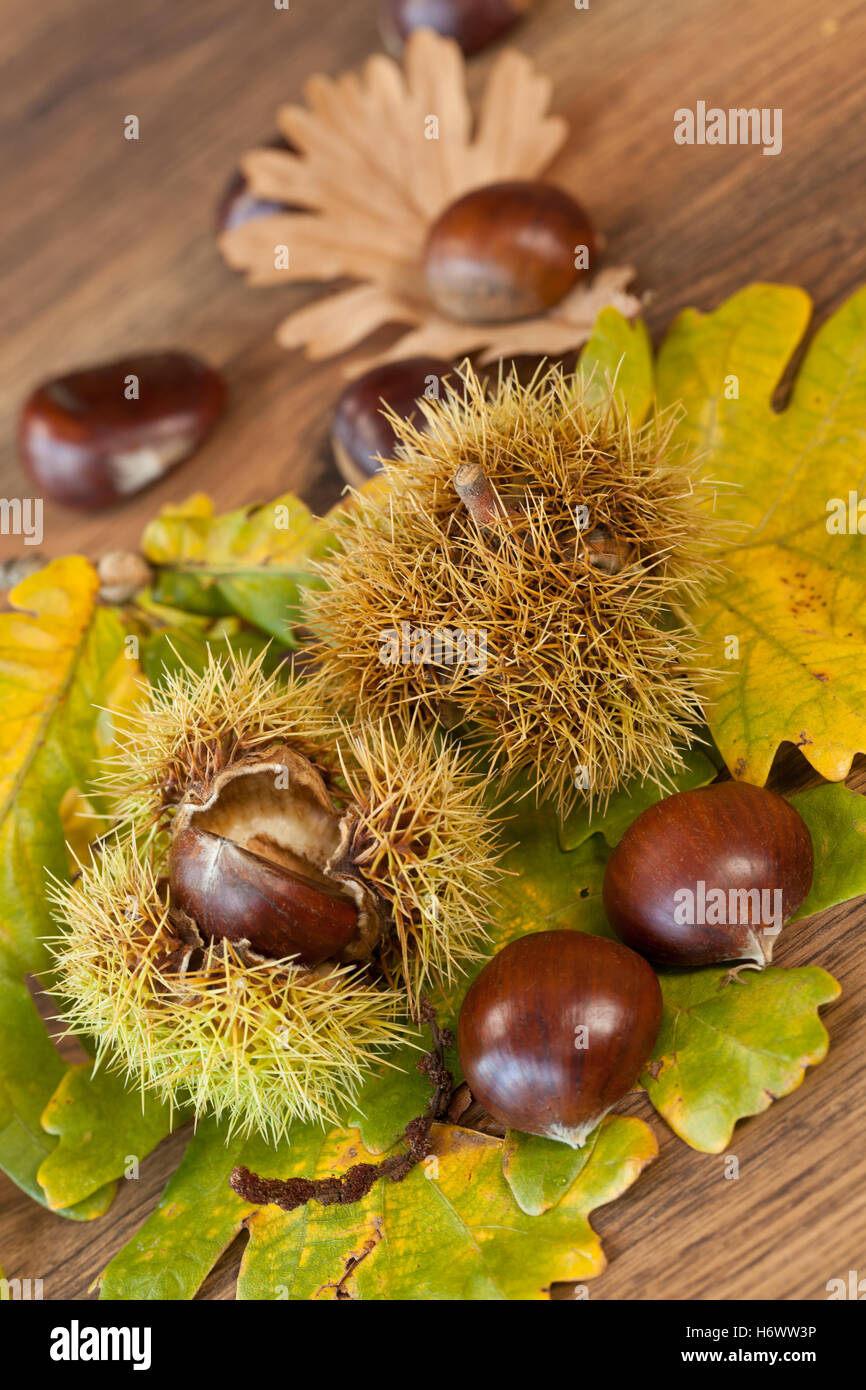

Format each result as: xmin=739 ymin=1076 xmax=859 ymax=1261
xmin=45 ymin=840 xmax=403 ymax=1143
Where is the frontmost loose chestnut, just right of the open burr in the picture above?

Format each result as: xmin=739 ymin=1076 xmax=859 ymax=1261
xmin=457 ymin=931 xmax=662 ymax=1148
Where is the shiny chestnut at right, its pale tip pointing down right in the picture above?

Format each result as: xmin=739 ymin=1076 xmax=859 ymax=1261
xmin=603 ymin=781 xmax=815 ymax=966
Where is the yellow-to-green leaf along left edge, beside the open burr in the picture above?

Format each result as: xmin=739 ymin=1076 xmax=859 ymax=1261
xmin=0 ymin=556 xmax=139 ymax=1218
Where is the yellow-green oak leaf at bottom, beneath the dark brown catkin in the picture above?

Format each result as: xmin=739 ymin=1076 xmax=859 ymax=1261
xmin=101 ymin=1120 xmax=655 ymax=1301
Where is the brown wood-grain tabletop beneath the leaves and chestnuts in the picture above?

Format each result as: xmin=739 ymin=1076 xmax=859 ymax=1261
xmin=0 ymin=0 xmax=866 ymax=1300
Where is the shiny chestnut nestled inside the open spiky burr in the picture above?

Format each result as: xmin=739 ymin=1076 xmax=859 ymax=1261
xmin=170 ymin=826 xmax=359 ymax=966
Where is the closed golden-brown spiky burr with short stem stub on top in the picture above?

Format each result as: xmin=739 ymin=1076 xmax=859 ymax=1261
xmin=309 ymin=368 xmax=719 ymax=810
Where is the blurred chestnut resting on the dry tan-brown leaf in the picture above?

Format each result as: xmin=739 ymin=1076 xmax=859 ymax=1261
xmin=424 ymin=179 xmax=595 ymax=322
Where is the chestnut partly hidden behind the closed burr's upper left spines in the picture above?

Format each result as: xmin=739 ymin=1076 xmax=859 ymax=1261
xmin=331 ymin=357 xmax=452 ymax=488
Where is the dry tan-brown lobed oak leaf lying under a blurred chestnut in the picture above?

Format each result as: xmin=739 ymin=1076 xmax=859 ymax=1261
xmin=220 ymin=29 xmax=639 ymax=374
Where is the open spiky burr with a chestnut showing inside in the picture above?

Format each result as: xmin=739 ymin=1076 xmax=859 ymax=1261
xmin=53 ymin=657 xmax=496 ymax=1138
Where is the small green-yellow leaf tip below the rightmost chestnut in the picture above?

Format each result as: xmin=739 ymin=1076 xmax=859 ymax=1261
xmin=641 ymin=966 xmax=840 ymax=1154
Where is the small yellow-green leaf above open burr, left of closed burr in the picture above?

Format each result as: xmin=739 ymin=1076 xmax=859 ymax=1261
xmin=142 ymin=492 xmax=334 ymax=646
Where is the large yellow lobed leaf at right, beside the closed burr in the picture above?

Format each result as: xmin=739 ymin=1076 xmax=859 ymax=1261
xmin=657 ymin=285 xmax=866 ymax=784
